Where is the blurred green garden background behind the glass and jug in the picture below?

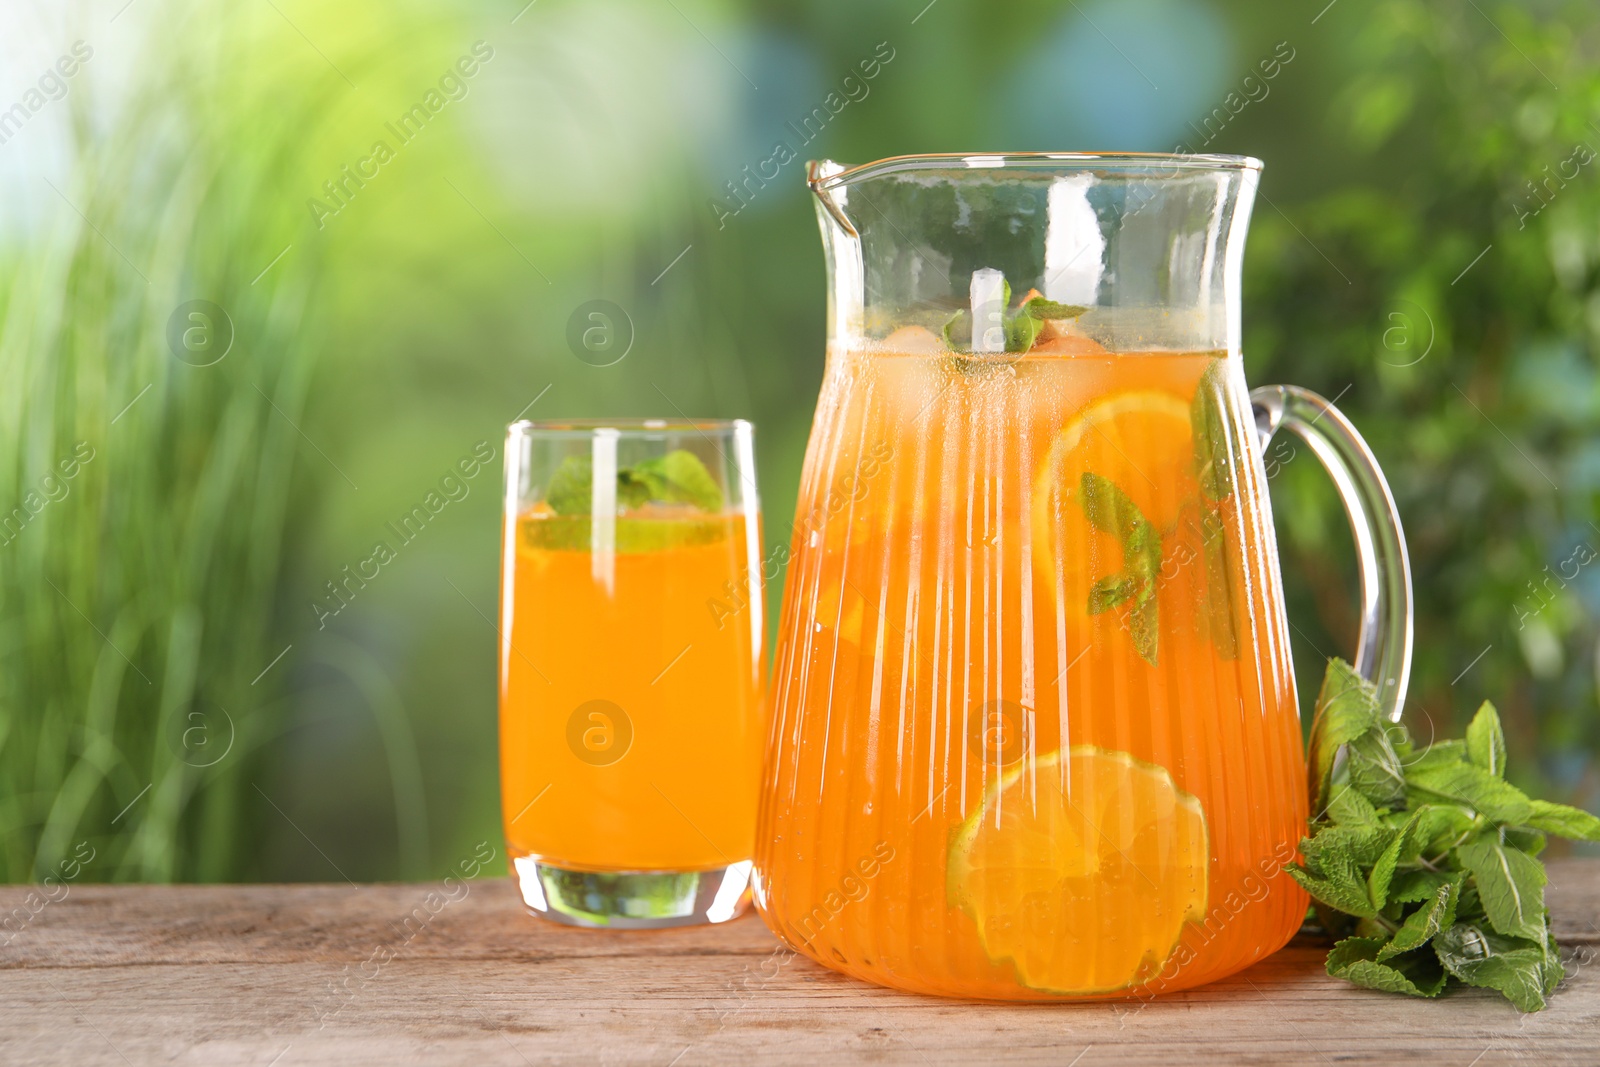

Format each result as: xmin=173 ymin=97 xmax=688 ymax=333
xmin=0 ymin=0 xmax=1600 ymax=880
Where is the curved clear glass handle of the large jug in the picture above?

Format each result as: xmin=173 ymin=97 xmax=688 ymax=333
xmin=1250 ymin=386 xmax=1411 ymax=721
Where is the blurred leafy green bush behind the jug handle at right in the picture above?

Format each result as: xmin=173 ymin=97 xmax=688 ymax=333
xmin=1245 ymin=2 xmax=1600 ymax=825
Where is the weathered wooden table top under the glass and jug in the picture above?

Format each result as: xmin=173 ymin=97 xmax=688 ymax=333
xmin=0 ymin=861 xmax=1600 ymax=1067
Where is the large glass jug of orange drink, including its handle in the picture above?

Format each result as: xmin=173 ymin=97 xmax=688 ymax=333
xmin=754 ymin=154 xmax=1411 ymax=1000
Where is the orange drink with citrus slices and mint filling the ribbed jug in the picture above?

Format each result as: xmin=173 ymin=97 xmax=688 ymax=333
xmin=755 ymin=343 xmax=1307 ymax=1000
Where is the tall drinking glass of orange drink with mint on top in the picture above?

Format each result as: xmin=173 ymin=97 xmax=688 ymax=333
xmin=499 ymin=419 xmax=765 ymax=928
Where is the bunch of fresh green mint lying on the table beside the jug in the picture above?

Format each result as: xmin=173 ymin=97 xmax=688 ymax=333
xmin=1290 ymin=659 xmax=1600 ymax=1011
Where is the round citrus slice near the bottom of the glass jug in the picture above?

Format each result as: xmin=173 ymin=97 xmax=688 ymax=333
xmin=946 ymin=745 xmax=1211 ymax=995
